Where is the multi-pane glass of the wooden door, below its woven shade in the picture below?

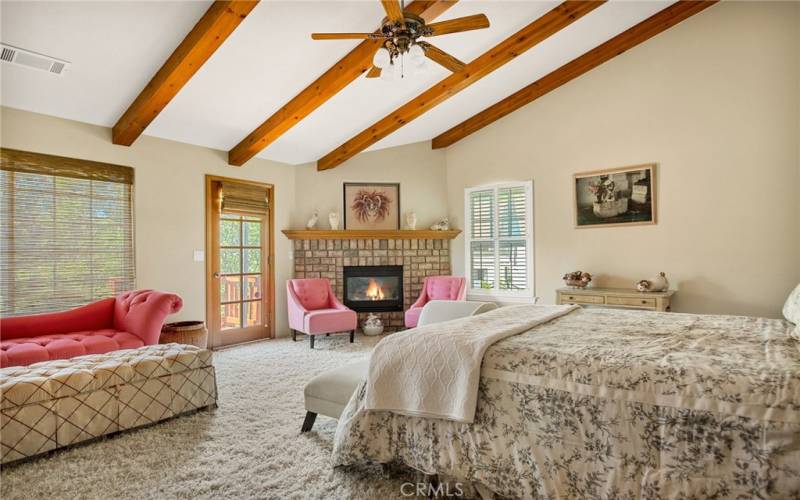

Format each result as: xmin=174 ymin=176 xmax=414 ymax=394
xmin=219 ymin=214 xmax=264 ymax=331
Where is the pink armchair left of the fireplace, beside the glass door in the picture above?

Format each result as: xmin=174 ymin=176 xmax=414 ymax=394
xmin=286 ymin=279 xmax=358 ymax=349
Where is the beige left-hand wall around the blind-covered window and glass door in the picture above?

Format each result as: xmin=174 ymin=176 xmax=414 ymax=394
xmin=0 ymin=108 xmax=294 ymax=335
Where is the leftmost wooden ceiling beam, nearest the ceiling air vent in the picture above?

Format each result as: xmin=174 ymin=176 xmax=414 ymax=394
xmin=111 ymin=0 xmax=258 ymax=146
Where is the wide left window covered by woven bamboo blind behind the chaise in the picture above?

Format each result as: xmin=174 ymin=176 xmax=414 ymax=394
xmin=0 ymin=148 xmax=135 ymax=317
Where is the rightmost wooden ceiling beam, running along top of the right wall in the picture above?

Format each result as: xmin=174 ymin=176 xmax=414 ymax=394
xmin=431 ymin=1 xmax=716 ymax=149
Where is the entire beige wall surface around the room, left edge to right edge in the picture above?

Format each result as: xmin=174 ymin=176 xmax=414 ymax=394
xmin=0 ymin=2 xmax=800 ymax=324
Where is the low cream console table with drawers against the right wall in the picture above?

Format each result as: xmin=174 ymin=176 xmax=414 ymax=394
xmin=556 ymin=288 xmax=675 ymax=311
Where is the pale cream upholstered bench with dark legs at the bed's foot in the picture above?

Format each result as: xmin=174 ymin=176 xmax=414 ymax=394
xmin=300 ymin=300 xmax=497 ymax=432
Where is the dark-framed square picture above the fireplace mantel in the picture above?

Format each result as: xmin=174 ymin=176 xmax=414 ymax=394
xmin=342 ymin=182 xmax=400 ymax=230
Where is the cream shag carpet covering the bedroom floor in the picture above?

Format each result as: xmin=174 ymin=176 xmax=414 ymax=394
xmin=0 ymin=335 xmax=407 ymax=500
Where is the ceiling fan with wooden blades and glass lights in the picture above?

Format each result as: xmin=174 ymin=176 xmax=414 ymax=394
xmin=311 ymin=0 xmax=489 ymax=80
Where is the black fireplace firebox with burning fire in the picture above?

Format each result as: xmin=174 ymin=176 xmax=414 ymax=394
xmin=344 ymin=266 xmax=403 ymax=312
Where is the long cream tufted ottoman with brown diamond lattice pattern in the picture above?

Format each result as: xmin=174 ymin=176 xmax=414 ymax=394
xmin=0 ymin=344 xmax=217 ymax=464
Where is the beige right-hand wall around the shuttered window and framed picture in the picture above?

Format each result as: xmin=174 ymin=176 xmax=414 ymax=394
xmin=446 ymin=2 xmax=800 ymax=317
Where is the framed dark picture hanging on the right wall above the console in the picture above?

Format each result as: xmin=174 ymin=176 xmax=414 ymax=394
xmin=573 ymin=163 xmax=656 ymax=228
